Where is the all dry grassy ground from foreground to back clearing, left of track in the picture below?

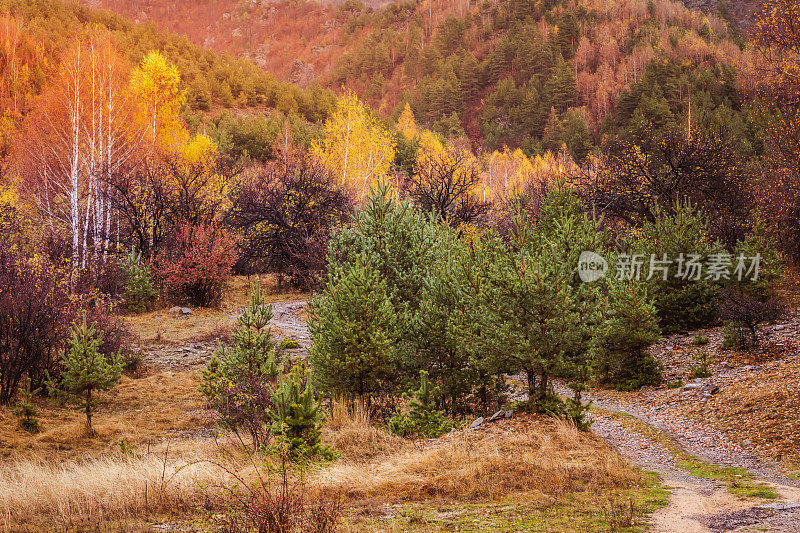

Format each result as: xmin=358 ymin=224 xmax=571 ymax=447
xmin=0 ymin=278 xmax=666 ymax=531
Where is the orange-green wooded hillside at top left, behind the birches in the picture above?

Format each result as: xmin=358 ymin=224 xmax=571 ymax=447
xmin=0 ymin=0 xmax=334 ymax=168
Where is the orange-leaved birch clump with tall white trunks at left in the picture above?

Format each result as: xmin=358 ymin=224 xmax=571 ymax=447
xmin=15 ymin=31 xmax=142 ymax=271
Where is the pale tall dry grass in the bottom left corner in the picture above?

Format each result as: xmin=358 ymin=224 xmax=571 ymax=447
xmin=0 ymin=438 xmax=226 ymax=531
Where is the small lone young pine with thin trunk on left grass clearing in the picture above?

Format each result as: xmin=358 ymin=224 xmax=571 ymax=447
xmin=61 ymin=313 xmax=123 ymax=433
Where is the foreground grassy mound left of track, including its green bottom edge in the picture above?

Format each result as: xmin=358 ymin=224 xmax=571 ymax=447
xmin=312 ymin=416 xmax=667 ymax=531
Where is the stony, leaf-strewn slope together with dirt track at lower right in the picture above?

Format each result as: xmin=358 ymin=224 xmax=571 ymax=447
xmin=562 ymin=312 xmax=800 ymax=532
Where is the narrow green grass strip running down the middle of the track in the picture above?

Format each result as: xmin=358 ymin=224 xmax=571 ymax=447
xmin=598 ymin=409 xmax=778 ymax=499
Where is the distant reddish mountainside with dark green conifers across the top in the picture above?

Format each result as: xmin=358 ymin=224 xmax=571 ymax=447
xmin=73 ymin=0 xmax=753 ymax=154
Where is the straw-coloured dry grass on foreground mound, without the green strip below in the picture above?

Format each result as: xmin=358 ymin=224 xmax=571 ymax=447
xmin=315 ymin=417 xmax=641 ymax=501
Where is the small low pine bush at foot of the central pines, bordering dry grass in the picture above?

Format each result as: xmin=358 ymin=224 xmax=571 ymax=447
xmin=387 ymin=370 xmax=453 ymax=439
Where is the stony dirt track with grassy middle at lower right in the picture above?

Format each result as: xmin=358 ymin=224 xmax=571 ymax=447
xmin=580 ymin=391 xmax=800 ymax=533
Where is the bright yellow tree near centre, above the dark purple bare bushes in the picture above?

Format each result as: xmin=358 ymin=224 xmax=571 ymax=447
xmin=311 ymin=92 xmax=395 ymax=199
